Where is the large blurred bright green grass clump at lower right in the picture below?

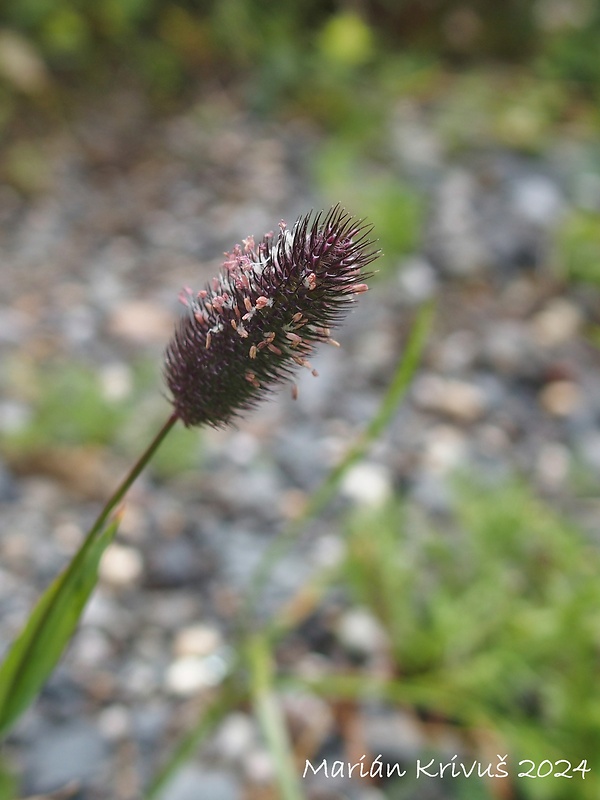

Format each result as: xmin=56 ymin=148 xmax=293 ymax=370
xmin=342 ymin=481 xmax=600 ymax=800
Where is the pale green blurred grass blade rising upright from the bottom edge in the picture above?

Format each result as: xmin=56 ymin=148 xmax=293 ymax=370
xmin=247 ymin=636 xmax=304 ymax=800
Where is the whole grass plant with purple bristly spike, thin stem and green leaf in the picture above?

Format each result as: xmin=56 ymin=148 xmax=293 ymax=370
xmin=0 ymin=206 xmax=379 ymax=756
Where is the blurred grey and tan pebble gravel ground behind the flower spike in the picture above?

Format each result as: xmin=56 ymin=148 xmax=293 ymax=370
xmin=0 ymin=89 xmax=600 ymax=800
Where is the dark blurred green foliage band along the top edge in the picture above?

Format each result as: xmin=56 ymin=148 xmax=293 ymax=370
xmin=0 ymin=0 xmax=600 ymax=114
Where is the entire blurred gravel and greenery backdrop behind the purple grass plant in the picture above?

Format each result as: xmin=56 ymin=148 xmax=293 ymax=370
xmin=0 ymin=0 xmax=600 ymax=800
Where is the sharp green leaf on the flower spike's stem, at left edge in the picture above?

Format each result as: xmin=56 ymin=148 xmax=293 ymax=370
xmin=0 ymin=517 xmax=120 ymax=735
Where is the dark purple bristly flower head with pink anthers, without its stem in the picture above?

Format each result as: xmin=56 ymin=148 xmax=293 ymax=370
xmin=165 ymin=206 xmax=379 ymax=426
